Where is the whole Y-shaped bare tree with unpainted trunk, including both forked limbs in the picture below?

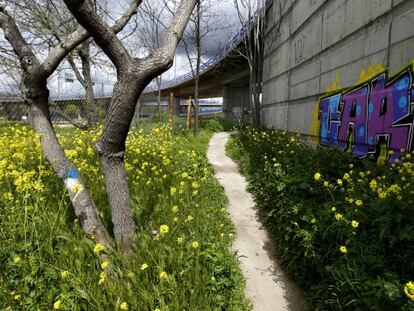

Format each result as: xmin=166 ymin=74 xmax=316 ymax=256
xmin=64 ymin=0 xmax=196 ymax=253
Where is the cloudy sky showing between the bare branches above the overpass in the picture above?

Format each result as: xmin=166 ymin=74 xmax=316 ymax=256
xmin=0 ymin=0 xmax=246 ymax=97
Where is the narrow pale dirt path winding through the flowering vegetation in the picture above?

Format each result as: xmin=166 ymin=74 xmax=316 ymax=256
xmin=207 ymin=133 xmax=303 ymax=311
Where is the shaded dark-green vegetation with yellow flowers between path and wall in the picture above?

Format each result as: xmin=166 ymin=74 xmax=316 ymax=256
xmin=228 ymin=128 xmax=414 ymax=310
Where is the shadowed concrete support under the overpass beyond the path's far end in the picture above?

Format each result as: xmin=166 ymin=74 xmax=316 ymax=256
xmin=223 ymin=86 xmax=251 ymax=121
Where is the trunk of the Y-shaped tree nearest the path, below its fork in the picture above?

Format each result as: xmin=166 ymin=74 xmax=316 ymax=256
xmin=97 ymin=74 xmax=142 ymax=255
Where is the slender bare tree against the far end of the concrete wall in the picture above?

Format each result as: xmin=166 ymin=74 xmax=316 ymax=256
xmin=233 ymin=0 xmax=288 ymax=125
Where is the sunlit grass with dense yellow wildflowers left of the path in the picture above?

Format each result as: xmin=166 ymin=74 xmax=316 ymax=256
xmin=0 ymin=125 xmax=249 ymax=311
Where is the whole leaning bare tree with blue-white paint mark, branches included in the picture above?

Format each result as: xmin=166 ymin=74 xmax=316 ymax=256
xmin=0 ymin=0 xmax=141 ymax=249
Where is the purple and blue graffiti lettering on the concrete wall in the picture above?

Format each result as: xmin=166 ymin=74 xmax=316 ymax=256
xmin=318 ymin=65 xmax=414 ymax=162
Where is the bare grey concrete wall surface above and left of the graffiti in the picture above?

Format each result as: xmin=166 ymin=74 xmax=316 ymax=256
xmin=262 ymin=0 xmax=414 ymax=135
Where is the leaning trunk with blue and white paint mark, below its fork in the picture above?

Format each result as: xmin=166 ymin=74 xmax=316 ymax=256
xmin=26 ymin=85 xmax=110 ymax=245
